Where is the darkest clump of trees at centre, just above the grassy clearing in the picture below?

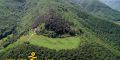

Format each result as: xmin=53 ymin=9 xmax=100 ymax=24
xmin=45 ymin=19 xmax=70 ymax=35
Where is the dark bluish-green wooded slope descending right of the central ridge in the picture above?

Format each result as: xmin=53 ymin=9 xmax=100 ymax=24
xmin=67 ymin=1 xmax=120 ymax=49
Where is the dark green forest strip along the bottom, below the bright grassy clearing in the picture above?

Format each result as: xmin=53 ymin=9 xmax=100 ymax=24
xmin=1 ymin=39 xmax=119 ymax=60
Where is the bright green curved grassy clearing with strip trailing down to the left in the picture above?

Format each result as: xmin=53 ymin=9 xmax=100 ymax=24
xmin=0 ymin=32 xmax=81 ymax=52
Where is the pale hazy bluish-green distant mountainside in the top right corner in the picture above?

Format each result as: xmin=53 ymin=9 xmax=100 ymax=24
xmin=70 ymin=0 xmax=120 ymax=21
